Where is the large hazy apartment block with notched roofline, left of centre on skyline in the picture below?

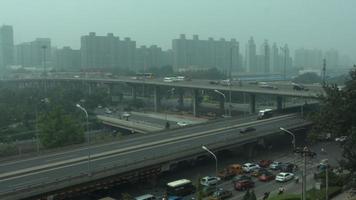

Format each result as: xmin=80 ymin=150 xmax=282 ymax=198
xmin=80 ymin=32 xmax=136 ymax=69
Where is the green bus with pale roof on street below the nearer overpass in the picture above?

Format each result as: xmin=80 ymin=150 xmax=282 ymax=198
xmin=166 ymin=179 xmax=195 ymax=196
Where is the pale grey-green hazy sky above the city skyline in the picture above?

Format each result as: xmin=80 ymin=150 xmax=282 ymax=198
xmin=0 ymin=0 xmax=356 ymax=58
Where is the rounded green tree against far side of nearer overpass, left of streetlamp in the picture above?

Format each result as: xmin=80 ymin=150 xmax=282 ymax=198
xmin=39 ymin=106 xmax=84 ymax=148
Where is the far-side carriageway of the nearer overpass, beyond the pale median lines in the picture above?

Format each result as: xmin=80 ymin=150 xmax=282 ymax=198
xmin=0 ymin=116 xmax=262 ymax=173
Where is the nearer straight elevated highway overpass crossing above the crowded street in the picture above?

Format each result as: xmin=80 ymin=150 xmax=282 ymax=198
xmin=0 ymin=114 xmax=311 ymax=199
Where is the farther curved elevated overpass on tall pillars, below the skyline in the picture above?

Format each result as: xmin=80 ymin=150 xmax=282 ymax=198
xmin=1 ymin=76 xmax=325 ymax=116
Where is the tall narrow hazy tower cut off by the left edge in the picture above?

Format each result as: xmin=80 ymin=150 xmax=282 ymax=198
xmin=0 ymin=25 xmax=14 ymax=67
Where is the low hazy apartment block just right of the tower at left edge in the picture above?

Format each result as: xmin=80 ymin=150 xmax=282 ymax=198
xmin=15 ymin=38 xmax=52 ymax=68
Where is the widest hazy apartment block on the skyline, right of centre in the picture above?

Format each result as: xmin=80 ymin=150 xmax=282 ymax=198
xmin=172 ymin=34 xmax=239 ymax=73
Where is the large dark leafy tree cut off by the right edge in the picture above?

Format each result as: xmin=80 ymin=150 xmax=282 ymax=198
xmin=312 ymin=65 xmax=356 ymax=172
